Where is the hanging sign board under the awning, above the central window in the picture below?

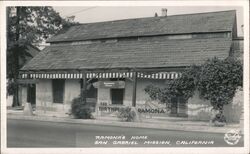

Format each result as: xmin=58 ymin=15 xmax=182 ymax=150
xmin=93 ymin=81 xmax=125 ymax=89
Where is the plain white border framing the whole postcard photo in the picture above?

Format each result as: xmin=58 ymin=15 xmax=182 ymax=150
xmin=0 ymin=0 xmax=249 ymax=154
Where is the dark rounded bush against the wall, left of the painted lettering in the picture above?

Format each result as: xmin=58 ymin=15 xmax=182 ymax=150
xmin=71 ymin=96 xmax=93 ymax=119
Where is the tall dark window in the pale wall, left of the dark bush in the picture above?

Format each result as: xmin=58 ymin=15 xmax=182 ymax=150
xmin=52 ymin=79 xmax=65 ymax=103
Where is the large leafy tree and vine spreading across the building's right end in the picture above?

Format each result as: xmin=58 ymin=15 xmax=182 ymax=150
xmin=144 ymin=58 xmax=243 ymax=110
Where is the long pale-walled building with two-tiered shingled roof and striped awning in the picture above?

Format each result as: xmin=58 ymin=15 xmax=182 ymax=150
xmin=20 ymin=10 xmax=243 ymax=120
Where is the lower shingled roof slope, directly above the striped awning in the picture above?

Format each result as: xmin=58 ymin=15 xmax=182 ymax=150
xmin=22 ymin=37 xmax=232 ymax=70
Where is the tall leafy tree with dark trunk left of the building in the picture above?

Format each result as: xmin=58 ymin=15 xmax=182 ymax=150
xmin=7 ymin=7 xmax=77 ymax=106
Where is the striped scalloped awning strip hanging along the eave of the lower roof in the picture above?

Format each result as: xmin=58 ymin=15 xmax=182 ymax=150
xmin=20 ymin=72 xmax=181 ymax=79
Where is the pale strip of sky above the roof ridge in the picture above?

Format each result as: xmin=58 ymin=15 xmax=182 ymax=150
xmin=54 ymin=6 xmax=243 ymax=36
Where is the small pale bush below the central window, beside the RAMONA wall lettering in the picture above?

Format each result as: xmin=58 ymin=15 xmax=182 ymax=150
xmin=118 ymin=107 xmax=136 ymax=122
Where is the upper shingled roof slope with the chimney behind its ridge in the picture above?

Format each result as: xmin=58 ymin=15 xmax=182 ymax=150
xmin=47 ymin=10 xmax=236 ymax=42
